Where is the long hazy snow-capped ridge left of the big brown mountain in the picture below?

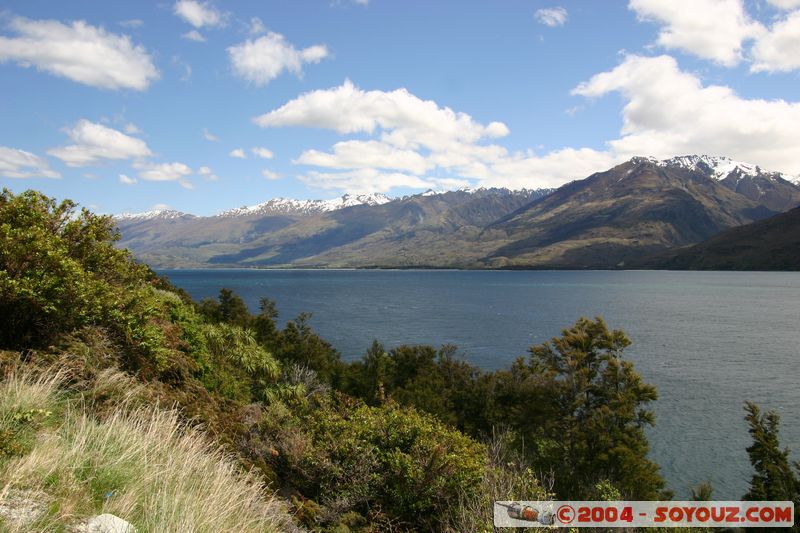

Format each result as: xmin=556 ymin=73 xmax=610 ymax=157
xmin=117 ymin=188 xmax=550 ymax=267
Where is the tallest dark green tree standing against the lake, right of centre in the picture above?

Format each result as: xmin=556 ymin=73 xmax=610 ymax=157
xmin=498 ymin=318 xmax=664 ymax=499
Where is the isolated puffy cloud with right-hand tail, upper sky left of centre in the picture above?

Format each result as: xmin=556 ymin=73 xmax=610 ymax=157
xmin=228 ymin=32 xmax=328 ymax=86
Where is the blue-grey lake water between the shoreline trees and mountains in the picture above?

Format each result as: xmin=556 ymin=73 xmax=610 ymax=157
xmin=161 ymin=269 xmax=800 ymax=499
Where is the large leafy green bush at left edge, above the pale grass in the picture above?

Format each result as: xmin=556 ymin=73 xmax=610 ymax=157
xmin=0 ymin=189 xmax=149 ymax=348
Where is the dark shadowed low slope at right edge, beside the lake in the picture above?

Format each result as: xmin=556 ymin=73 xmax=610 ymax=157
xmin=639 ymin=207 xmax=800 ymax=270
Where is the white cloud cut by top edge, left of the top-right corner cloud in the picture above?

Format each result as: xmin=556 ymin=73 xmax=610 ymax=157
xmin=628 ymin=0 xmax=765 ymax=67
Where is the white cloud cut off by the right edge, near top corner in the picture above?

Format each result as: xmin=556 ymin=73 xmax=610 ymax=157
xmin=750 ymin=10 xmax=800 ymax=72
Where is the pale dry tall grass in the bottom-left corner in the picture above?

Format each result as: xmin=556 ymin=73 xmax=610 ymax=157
xmin=0 ymin=370 xmax=294 ymax=533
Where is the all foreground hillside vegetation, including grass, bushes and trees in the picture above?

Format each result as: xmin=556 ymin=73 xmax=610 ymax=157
xmin=0 ymin=186 xmax=800 ymax=533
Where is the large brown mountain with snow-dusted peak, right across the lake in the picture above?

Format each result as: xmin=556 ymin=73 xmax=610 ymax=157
xmin=481 ymin=158 xmax=774 ymax=268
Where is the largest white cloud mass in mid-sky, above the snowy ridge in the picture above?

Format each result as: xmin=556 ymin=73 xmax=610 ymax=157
xmin=254 ymin=81 xmax=615 ymax=192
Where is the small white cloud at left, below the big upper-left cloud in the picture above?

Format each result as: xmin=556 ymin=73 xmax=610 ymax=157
xmin=47 ymin=119 xmax=152 ymax=167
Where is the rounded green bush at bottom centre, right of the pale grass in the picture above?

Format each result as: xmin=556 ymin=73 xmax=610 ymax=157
xmin=262 ymin=397 xmax=486 ymax=530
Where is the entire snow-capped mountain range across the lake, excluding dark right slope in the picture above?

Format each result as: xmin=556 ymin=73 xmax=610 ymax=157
xmin=116 ymin=156 xmax=800 ymax=268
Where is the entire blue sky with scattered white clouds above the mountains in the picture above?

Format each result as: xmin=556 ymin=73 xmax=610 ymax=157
xmin=0 ymin=0 xmax=800 ymax=214
